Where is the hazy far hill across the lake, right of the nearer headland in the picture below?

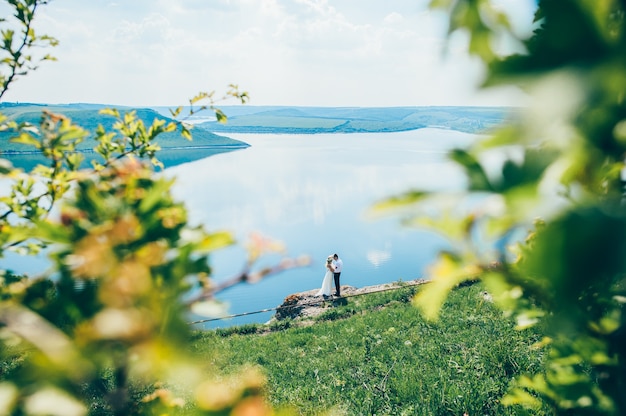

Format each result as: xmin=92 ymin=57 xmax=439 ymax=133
xmin=189 ymin=106 xmax=516 ymax=134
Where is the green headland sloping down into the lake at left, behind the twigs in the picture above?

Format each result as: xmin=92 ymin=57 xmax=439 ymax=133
xmin=0 ymin=103 xmax=247 ymax=152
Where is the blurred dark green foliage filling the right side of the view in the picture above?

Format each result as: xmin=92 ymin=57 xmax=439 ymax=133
xmin=378 ymin=0 xmax=626 ymax=415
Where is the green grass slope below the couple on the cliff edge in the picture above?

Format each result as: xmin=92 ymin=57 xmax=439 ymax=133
xmin=193 ymin=285 xmax=544 ymax=415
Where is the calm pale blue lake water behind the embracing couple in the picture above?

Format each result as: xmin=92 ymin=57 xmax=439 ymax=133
xmin=166 ymin=129 xmax=474 ymax=328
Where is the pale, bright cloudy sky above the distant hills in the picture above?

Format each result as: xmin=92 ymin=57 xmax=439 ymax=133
xmin=0 ymin=0 xmax=534 ymax=107
